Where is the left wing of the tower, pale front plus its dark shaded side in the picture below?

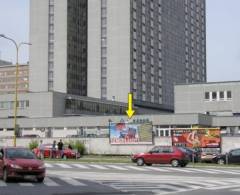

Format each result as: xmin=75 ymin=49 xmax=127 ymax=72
xmin=29 ymin=0 xmax=87 ymax=96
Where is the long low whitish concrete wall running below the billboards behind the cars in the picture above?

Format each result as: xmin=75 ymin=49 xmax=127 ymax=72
xmin=0 ymin=137 xmax=240 ymax=155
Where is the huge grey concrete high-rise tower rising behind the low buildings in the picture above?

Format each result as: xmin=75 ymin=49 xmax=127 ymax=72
xmin=30 ymin=0 xmax=206 ymax=109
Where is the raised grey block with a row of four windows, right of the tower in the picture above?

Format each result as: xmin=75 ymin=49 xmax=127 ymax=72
xmin=174 ymin=81 xmax=240 ymax=116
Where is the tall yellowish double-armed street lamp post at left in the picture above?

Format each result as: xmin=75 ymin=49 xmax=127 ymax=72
xmin=0 ymin=34 xmax=31 ymax=147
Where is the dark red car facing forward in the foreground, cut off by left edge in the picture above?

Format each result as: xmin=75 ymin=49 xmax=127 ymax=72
xmin=0 ymin=147 xmax=45 ymax=182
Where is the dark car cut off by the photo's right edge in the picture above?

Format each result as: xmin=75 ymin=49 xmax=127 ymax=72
xmin=213 ymin=148 xmax=240 ymax=164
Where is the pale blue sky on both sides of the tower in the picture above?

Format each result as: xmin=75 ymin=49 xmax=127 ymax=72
xmin=0 ymin=0 xmax=240 ymax=82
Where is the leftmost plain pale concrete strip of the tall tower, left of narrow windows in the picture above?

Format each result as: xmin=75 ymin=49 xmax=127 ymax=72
xmin=29 ymin=0 xmax=49 ymax=92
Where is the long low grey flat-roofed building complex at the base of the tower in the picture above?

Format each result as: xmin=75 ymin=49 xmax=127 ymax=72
xmin=0 ymin=81 xmax=240 ymax=152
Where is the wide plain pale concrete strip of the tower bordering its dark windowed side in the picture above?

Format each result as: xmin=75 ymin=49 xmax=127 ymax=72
xmin=107 ymin=0 xmax=131 ymax=102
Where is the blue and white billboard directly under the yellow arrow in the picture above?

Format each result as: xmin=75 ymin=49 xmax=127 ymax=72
xmin=109 ymin=122 xmax=153 ymax=144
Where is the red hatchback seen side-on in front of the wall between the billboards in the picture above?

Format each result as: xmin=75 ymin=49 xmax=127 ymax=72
xmin=132 ymin=146 xmax=189 ymax=167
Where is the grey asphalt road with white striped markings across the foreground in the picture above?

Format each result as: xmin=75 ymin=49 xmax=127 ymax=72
xmin=0 ymin=163 xmax=240 ymax=195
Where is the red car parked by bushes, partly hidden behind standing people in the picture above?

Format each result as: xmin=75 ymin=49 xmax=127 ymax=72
xmin=33 ymin=144 xmax=80 ymax=158
